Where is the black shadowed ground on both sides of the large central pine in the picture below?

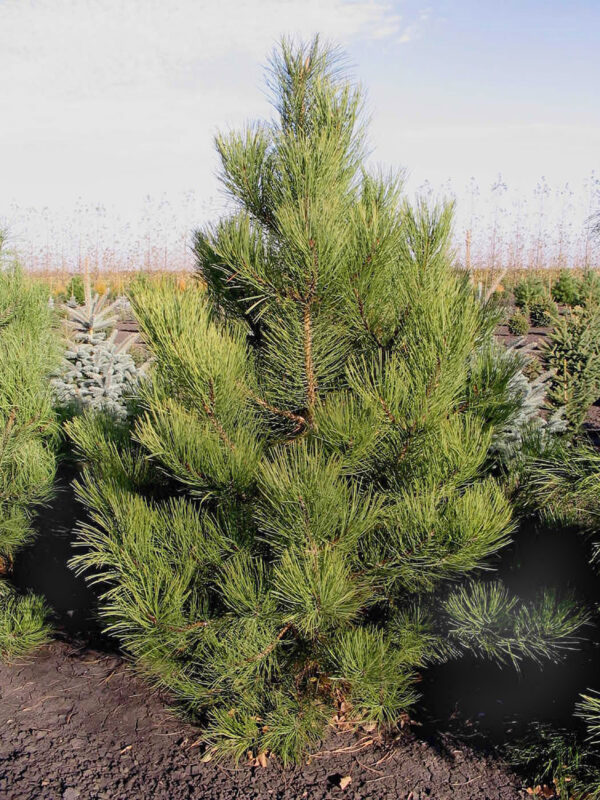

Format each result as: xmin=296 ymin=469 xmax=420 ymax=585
xmin=13 ymin=462 xmax=600 ymax=764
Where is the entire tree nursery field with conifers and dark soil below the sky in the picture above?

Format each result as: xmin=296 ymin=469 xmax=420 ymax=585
xmin=0 ymin=38 xmax=600 ymax=800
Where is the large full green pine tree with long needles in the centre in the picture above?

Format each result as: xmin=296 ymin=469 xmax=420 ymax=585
xmin=69 ymin=40 xmax=581 ymax=762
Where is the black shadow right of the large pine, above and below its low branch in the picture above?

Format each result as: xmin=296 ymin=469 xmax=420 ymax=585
xmin=420 ymin=521 xmax=600 ymax=749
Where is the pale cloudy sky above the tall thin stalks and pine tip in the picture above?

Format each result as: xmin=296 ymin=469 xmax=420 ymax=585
xmin=0 ymin=0 xmax=600 ymax=264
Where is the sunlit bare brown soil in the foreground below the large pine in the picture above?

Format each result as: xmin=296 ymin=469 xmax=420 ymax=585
xmin=0 ymin=642 xmax=525 ymax=800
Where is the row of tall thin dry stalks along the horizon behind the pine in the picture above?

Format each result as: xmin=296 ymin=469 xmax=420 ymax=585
xmin=0 ymin=173 xmax=600 ymax=276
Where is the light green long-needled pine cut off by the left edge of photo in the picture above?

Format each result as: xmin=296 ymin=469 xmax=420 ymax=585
xmin=0 ymin=258 xmax=57 ymax=660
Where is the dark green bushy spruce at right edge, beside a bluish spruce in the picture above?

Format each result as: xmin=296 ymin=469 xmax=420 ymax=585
xmin=543 ymin=306 xmax=600 ymax=430
